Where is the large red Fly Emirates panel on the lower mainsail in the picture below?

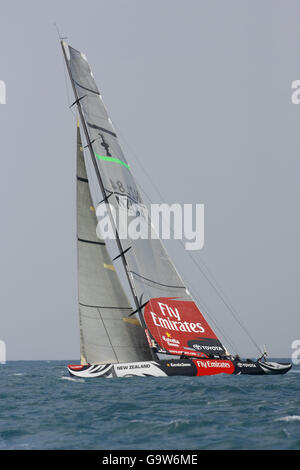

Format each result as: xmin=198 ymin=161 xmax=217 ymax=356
xmin=144 ymin=297 xmax=217 ymax=350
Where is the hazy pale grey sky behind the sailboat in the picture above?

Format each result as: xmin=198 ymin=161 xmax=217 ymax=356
xmin=0 ymin=0 xmax=300 ymax=360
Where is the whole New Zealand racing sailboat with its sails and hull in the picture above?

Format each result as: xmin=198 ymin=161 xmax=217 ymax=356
xmin=61 ymin=39 xmax=291 ymax=378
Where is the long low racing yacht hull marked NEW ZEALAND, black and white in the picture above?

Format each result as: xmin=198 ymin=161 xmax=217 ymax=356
xmin=68 ymin=359 xmax=292 ymax=378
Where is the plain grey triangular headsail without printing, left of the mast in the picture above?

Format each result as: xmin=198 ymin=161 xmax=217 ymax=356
xmin=77 ymin=121 xmax=151 ymax=364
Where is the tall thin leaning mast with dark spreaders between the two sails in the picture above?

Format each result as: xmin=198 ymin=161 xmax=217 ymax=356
xmin=60 ymin=39 xmax=157 ymax=360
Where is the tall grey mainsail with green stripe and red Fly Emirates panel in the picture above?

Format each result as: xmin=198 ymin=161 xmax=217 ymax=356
xmin=63 ymin=43 xmax=225 ymax=357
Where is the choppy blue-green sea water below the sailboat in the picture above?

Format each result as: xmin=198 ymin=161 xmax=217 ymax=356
xmin=0 ymin=361 xmax=300 ymax=450
